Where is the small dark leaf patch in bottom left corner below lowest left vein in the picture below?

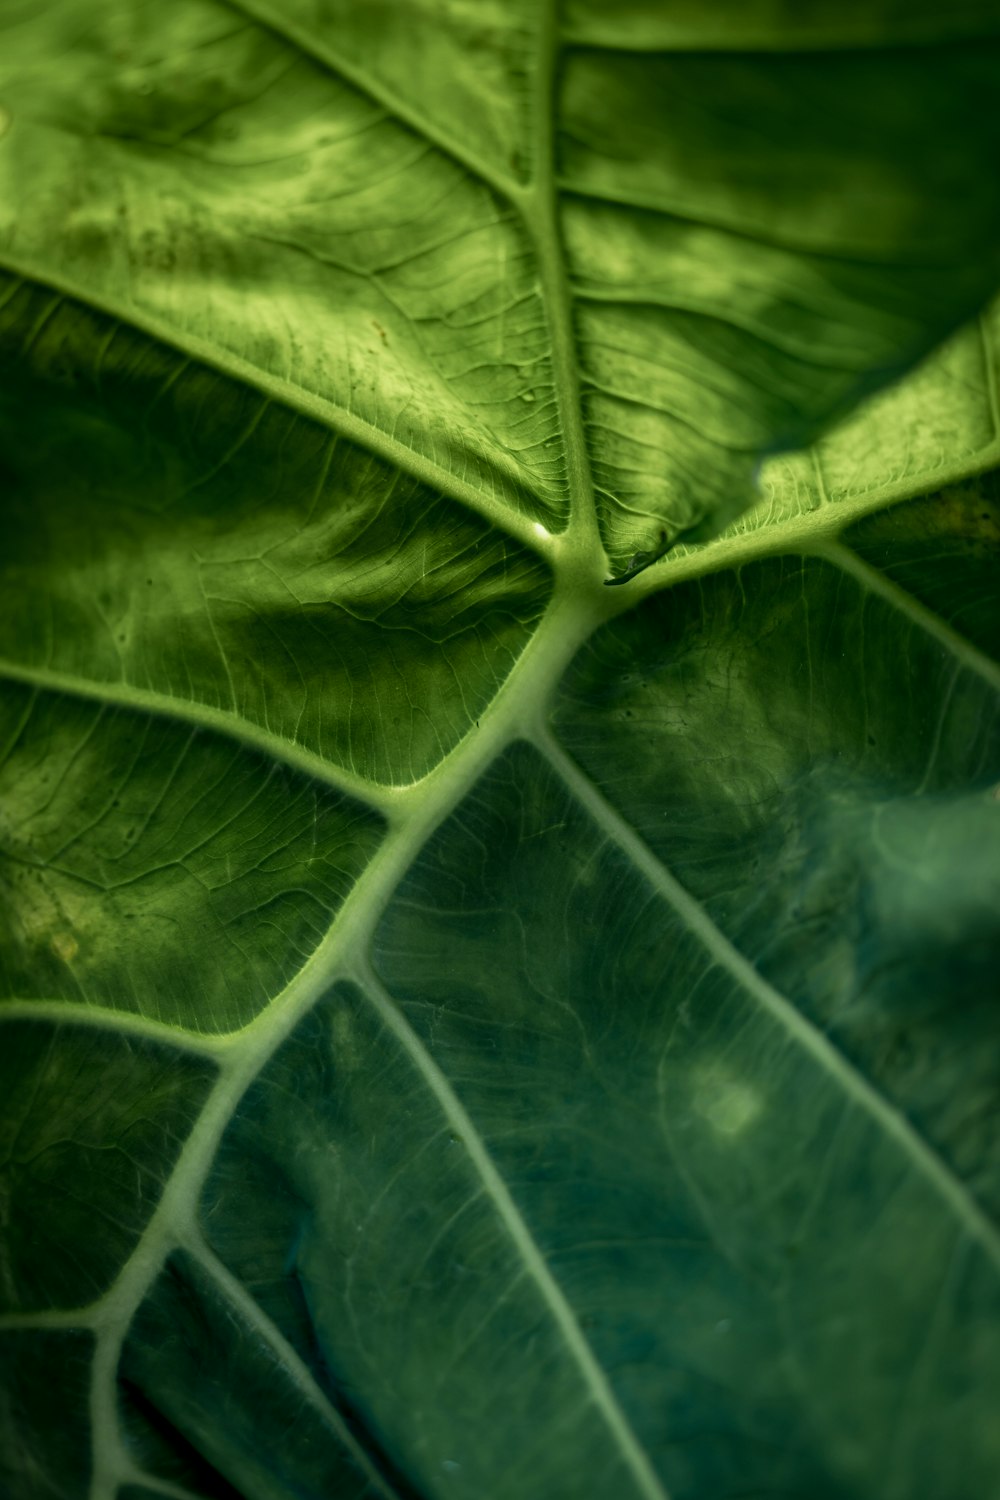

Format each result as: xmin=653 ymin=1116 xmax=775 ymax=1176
xmin=0 ymin=1329 xmax=93 ymax=1500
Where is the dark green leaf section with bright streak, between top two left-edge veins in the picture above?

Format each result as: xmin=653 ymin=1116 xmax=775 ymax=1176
xmin=0 ymin=288 xmax=549 ymax=783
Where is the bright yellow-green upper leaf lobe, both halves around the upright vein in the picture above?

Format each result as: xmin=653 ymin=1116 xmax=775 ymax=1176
xmin=0 ymin=0 xmax=1000 ymax=570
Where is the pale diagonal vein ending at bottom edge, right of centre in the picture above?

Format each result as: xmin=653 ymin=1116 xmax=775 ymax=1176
xmin=357 ymin=959 xmax=669 ymax=1500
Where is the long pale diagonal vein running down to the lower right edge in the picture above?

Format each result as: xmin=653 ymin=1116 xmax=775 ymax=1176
xmin=537 ymin=731 xmax=1000 ymax=1269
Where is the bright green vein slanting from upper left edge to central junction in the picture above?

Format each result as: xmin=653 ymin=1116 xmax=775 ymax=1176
xmin=0 ymin=252 xmax=552 ymax=557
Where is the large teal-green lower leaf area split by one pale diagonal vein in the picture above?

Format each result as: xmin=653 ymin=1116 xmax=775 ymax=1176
xmin=182 ymin=747 xmax=1000 ymax=1500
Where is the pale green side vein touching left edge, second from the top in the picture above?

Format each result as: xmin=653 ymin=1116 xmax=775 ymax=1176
xmin=0 ymin=659 xmax=406 ymax=818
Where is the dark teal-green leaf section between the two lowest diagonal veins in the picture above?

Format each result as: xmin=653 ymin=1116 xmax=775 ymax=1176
xmin=202 ymin=984 xmax=634 ymax=1500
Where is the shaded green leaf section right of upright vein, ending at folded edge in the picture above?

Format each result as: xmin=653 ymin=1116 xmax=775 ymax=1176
xmin=556 ymin=35 xmax=1000 ymax=572
